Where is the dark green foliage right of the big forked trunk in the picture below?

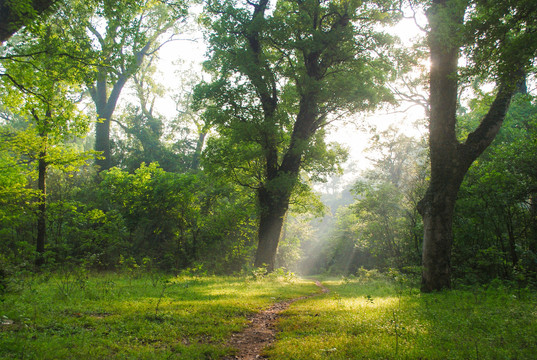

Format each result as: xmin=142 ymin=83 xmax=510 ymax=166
xmin=454 ymin=94 xmax=537 ymax=283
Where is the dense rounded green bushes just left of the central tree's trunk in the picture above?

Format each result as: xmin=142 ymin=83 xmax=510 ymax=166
xmin=100 ymin=164 xmax=255 ymax=271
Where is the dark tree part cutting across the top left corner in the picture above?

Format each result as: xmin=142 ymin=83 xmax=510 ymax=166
xmin=0 ymin=0 xmax=56 ymax=43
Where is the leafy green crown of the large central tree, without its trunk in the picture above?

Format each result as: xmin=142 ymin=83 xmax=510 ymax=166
xmin=196 ymin=1 xmax=393 ymax=188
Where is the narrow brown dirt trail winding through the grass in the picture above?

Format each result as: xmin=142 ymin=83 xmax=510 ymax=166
xmin=223 ymin=280 xmax=329 ymax=360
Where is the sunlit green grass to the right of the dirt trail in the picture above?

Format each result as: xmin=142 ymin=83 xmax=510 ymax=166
xmin=267 ymin=279 xmax=537 ymax=360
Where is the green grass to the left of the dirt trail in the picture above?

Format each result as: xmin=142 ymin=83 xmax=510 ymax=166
xmin=0 ymin=272 xmax=317 ymax=359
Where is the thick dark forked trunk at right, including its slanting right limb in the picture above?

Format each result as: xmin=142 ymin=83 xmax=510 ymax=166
xmin=418 ymin=0 xmax=516 ymax=292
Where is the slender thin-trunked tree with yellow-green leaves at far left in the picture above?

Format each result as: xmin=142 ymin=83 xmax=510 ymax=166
xmin=2 ymin=23 xmax=89 ymax=265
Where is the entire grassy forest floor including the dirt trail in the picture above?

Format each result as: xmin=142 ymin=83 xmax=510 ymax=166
xmin=0 ymin=270 xmax=537 ymax=360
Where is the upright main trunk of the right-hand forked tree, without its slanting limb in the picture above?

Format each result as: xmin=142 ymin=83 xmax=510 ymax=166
xmin=419 ymin=0 xmax=462 ymax=291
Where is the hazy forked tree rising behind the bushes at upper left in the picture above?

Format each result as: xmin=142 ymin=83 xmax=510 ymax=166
xmin=64 ymin=0 xmax=187 ymax=170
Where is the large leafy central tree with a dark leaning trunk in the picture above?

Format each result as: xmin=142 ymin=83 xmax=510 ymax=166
xmin=198 ymin=0 xmax=394 ymax=271
